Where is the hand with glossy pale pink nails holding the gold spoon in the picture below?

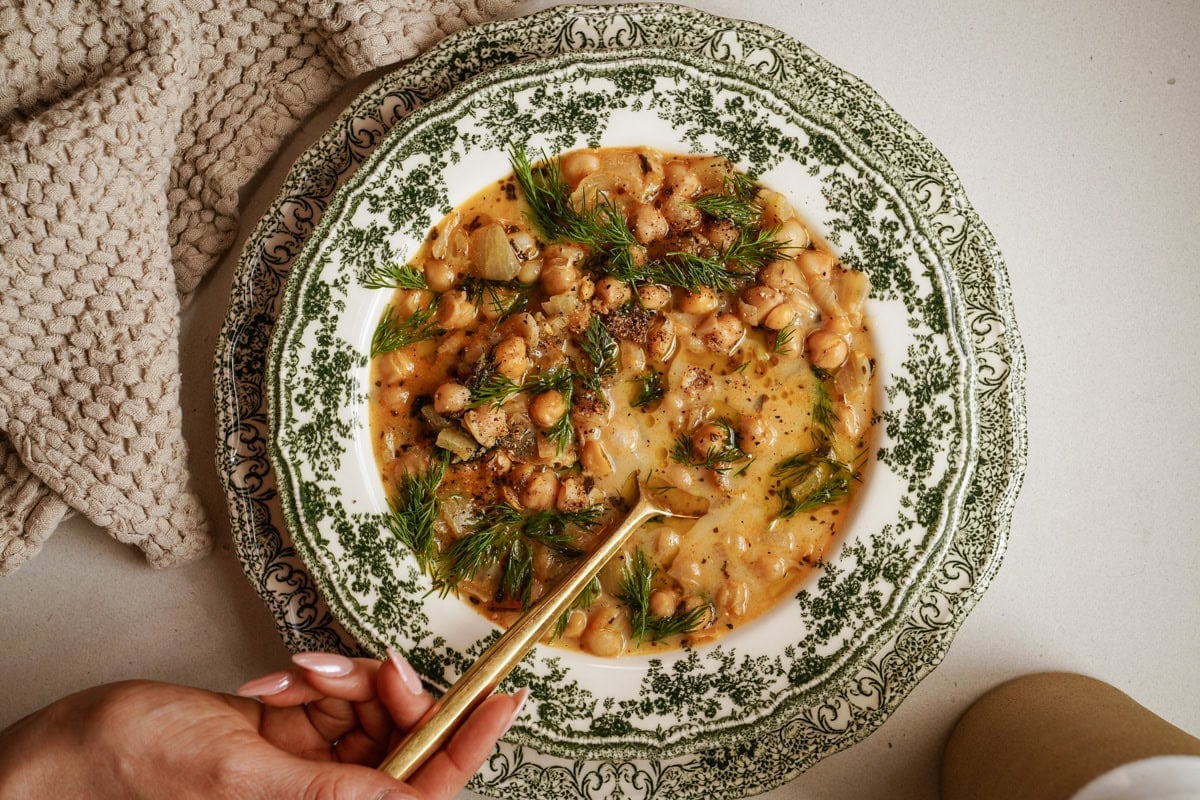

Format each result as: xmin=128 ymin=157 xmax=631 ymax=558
xmin=0 ymin=652 xmax=526 ymax=800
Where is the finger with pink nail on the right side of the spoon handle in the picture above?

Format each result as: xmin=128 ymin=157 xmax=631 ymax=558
xmin=408 ymin=688 xmax=529 ymax=800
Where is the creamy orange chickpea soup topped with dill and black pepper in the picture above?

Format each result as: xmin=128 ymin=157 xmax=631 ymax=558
xmin=370 ymin=148 xmax=874 ymax=656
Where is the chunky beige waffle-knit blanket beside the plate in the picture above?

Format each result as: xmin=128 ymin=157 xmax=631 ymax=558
xmin=0 ymin=0 xmax=517 ymax=575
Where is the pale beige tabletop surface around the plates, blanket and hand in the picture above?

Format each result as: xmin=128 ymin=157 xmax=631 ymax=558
xmin=0 ymin=0 xmax=1200 ymax=800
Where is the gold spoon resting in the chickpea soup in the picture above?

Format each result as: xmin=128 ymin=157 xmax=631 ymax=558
xmin=379 ymin=481 xmax=703 ymax=781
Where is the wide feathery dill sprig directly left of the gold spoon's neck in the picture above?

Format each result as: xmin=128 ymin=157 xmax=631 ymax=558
xmin=442 ymin=503 xmax=602 ymax=607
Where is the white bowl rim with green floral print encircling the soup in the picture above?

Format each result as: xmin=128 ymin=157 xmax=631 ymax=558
xmin=266 ymin=43 xmax=1024 ymax=769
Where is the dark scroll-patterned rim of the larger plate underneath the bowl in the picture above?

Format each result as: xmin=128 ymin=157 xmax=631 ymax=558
xmin=217 ymin=6 xmax=1025 ymax=798
